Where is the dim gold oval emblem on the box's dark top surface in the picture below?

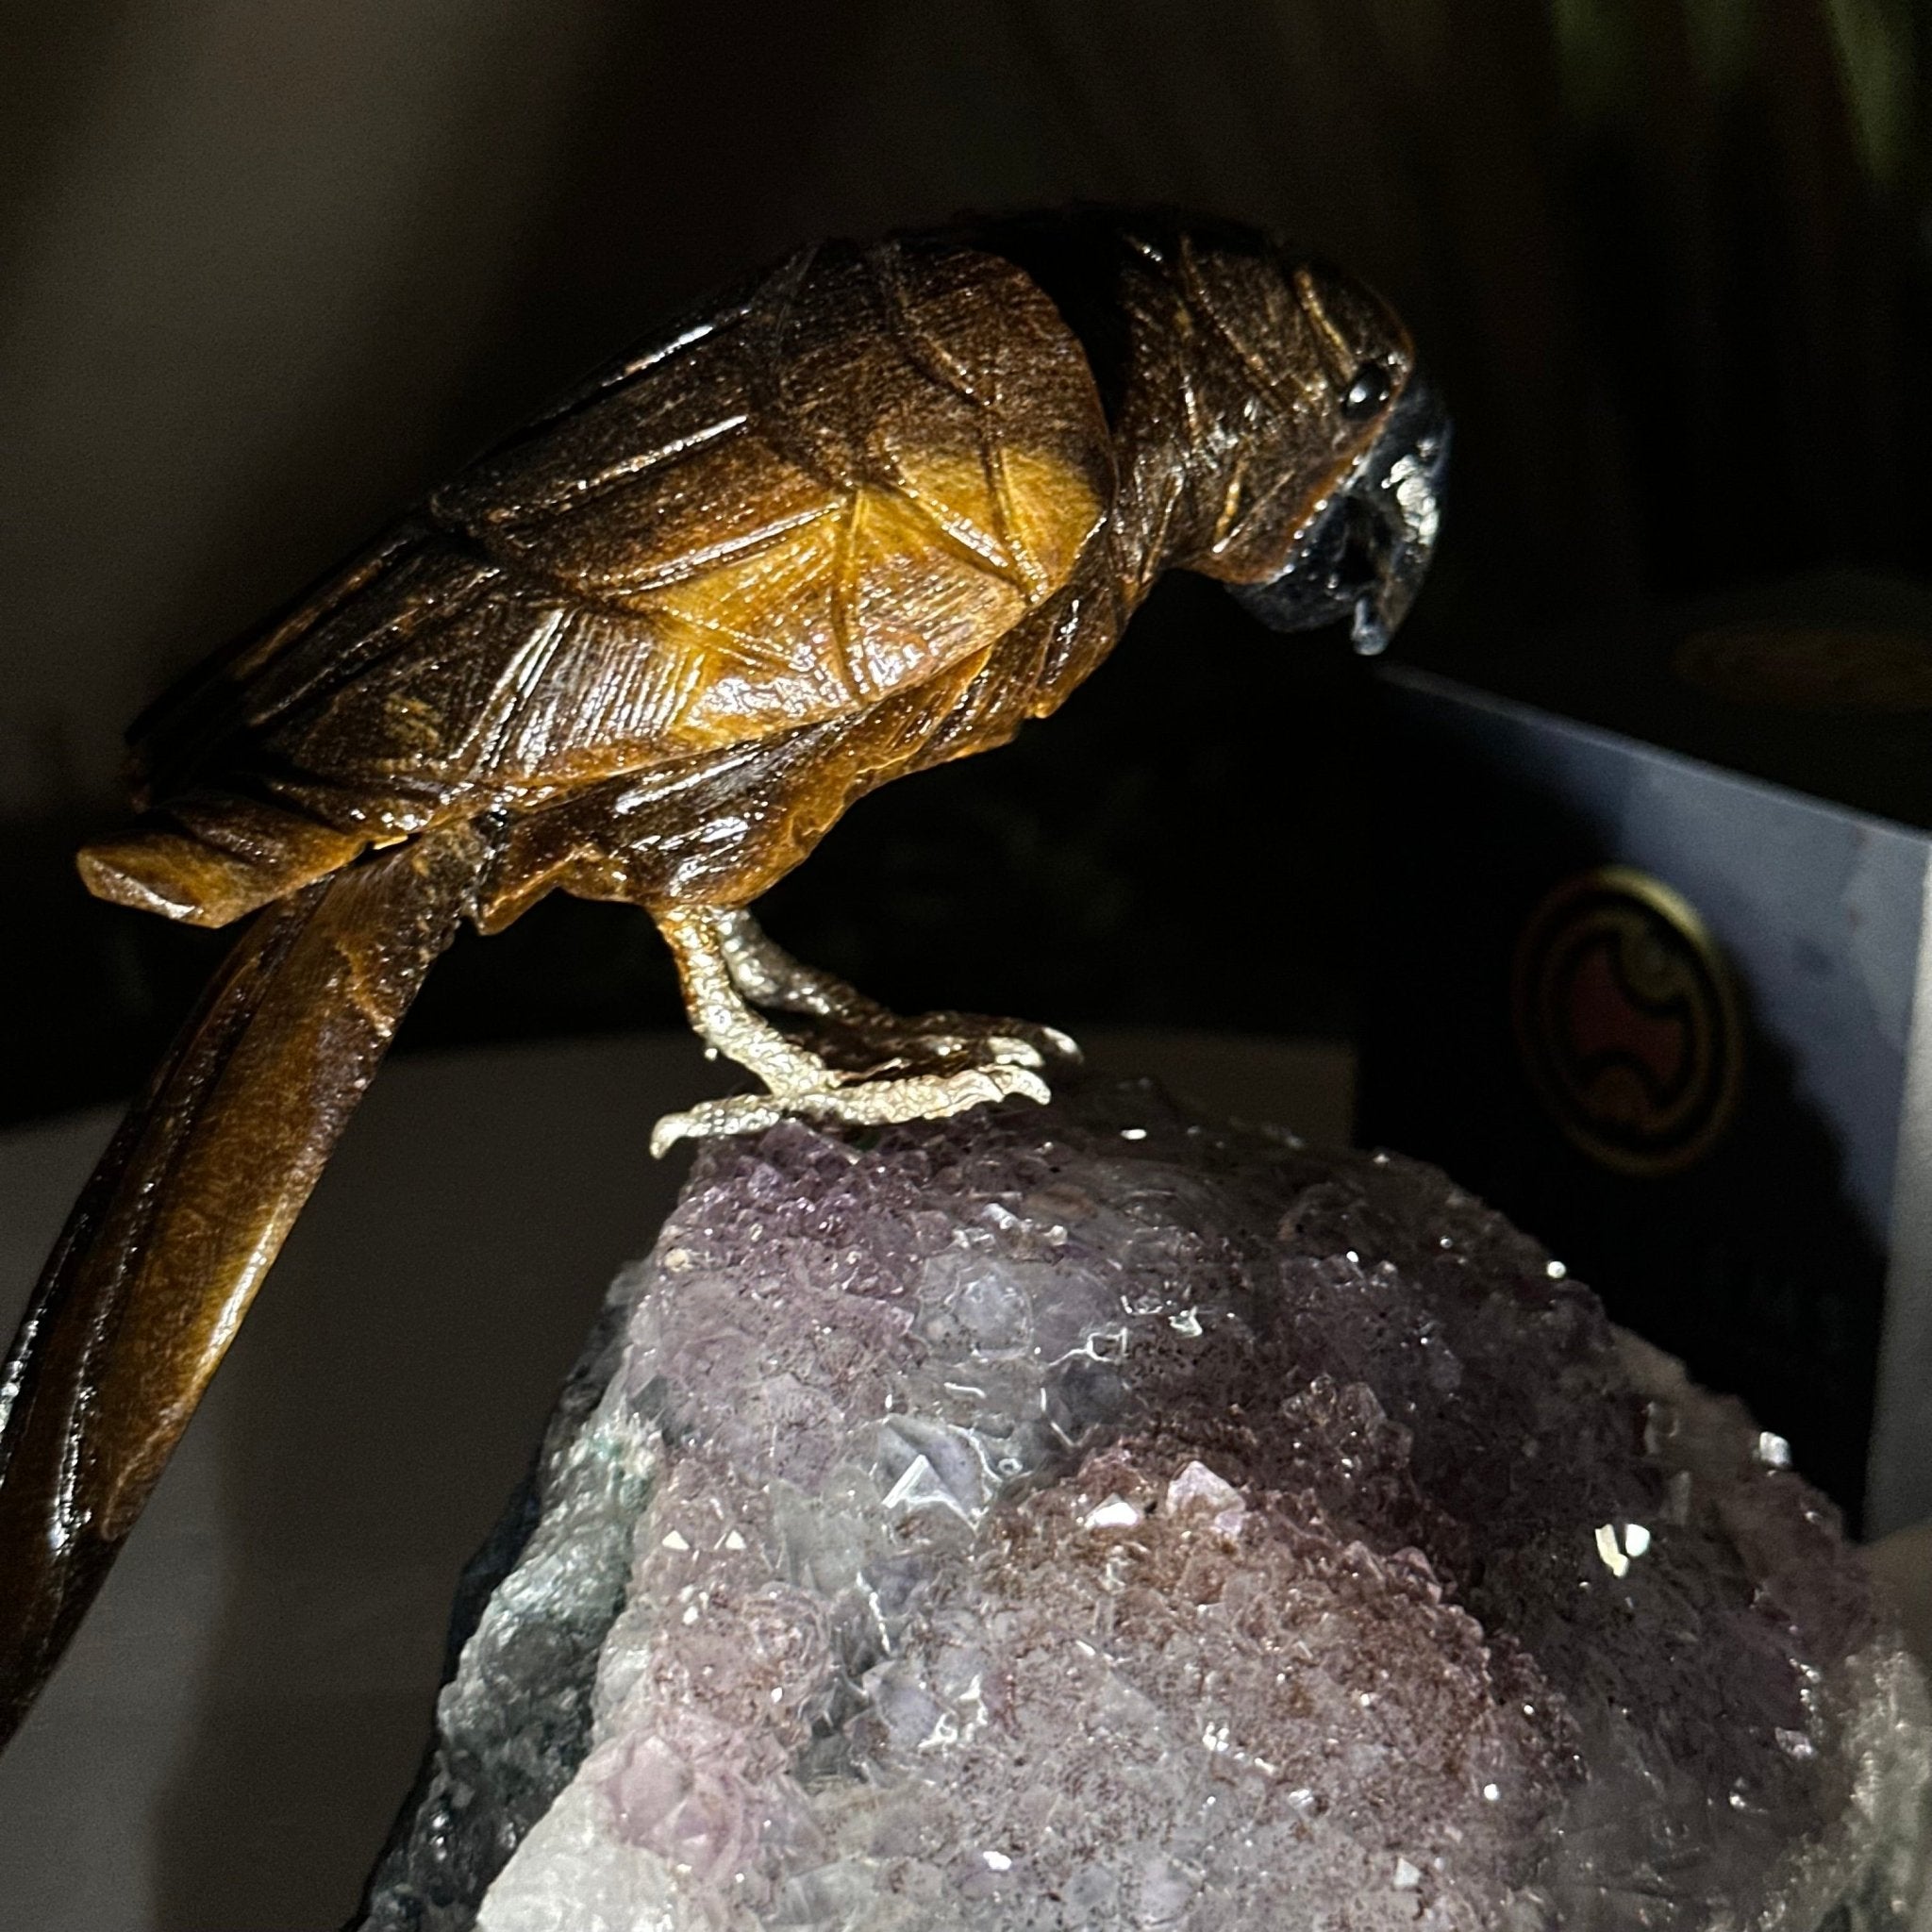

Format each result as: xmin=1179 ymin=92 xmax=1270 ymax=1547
xmin=1675 ymin=625 xmax=1932 ymax=711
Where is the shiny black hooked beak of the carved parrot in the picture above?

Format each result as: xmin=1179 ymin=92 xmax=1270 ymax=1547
xmin=1229 ymin=375 xmax=1449 ymax=655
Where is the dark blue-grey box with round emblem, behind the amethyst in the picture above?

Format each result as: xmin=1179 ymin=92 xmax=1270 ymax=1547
xmin=1358 ymin=575 xmax=1932 ymax=1534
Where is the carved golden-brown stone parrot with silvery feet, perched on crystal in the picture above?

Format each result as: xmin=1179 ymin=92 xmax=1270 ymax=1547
xmin=0 ymin=210 xmax=1447 ymax=1739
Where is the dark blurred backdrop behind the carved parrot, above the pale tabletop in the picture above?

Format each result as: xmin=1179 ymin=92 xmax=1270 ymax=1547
xmin=0 ymin=0 xmax=1932 ymax=1121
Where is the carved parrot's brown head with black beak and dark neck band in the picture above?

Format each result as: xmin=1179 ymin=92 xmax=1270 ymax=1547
xmin=962 ymin=207 xmax=1449 ymax=651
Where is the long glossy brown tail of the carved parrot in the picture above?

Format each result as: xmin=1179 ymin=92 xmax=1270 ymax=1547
xmin=0 ymin=827 xmax=481 ymax=1744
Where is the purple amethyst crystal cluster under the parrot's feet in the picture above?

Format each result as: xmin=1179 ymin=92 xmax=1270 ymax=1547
xmin=363 ymin=1084 xmax=1932 ymax=1932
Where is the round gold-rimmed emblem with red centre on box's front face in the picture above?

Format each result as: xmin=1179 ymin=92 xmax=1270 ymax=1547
xmin=1513 ymin=866 xmax=1742 ymax=1176
